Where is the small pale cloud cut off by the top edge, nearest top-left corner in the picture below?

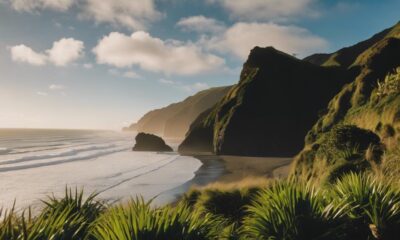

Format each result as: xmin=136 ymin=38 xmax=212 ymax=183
xmin=10 ymin=0 xmax=76 ymax=12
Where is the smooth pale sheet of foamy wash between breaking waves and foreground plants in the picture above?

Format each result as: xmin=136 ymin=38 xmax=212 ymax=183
xmin=0 ymin=151 xmax=201 ymax=211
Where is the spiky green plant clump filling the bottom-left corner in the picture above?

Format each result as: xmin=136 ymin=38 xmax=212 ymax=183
xmin=0 ymin=188 xmax=105 ymax=240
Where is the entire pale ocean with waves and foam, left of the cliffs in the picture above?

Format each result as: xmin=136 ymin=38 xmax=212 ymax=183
xmin=0 ymin=129 xmax=202 ymax=209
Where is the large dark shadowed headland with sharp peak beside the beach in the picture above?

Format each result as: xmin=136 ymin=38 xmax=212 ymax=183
xmin=179 ymin=47 xmax=354 ymax=157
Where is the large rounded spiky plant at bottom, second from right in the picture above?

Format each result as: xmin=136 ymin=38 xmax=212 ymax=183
xmin=244 ymin=181 xmax=344 ymax=240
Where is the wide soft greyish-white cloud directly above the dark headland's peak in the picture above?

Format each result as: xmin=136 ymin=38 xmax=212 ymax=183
xmin=200 ymin=22 xmax=328 ymax=59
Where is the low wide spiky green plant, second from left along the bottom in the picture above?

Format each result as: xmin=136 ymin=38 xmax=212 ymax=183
xmin=91 ymin=199 xmax=222 ymax=240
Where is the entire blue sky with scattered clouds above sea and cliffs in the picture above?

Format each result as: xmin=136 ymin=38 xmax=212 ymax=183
xmin=0 ymin=0 xmax=400 ymax=129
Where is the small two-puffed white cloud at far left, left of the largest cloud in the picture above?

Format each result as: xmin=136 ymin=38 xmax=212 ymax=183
xmin=10 ymin=38 xmax=84 ymax=66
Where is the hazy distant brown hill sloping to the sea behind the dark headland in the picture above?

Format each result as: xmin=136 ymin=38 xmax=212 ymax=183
xmin=123 ymin=86 xmax=231 ymax=139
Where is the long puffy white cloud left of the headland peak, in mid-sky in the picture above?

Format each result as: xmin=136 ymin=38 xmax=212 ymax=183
xmin=93 ymin=31 xmax=224 ymax=75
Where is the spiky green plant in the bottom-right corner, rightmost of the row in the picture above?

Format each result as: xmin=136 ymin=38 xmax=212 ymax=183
xmin=332 ymin=173 xmax=400 ymax=240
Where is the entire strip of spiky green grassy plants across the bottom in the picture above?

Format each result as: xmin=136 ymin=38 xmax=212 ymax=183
xmin=0 ymin=173 xmax=400 ymax=240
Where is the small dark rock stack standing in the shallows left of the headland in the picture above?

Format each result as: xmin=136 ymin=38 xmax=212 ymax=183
xmin=132 ymin=132 xmax=173 ymax=152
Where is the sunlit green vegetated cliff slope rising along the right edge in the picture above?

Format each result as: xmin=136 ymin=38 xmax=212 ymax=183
xmin=292 ymin=24 xmax=400 ymax=182
